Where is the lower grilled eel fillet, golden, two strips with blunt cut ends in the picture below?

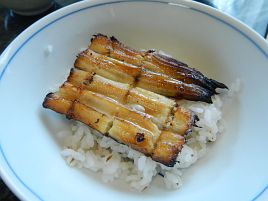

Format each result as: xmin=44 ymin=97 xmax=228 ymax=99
xmin=43 ymin=68 xmax=196 ymax=167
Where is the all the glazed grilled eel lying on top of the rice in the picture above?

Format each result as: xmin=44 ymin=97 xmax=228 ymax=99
xmin=43 ymin=34 xmax=227 ymax=167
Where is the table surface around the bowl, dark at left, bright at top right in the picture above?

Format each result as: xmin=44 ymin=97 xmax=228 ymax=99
xmin=0 ymin=0 xmax=268 ymax=201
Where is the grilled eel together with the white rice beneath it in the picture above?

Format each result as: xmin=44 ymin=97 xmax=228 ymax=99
xmin=43 ymin=34 xmax=239 ymax=191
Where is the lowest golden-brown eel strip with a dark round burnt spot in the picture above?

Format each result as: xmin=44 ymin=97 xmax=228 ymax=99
xmin=43 ymin=82 xmax=186 ymax=166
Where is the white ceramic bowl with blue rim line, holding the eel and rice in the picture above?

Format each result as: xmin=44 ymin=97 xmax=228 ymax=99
xmin=0 ymin=0 xmax=268 ymax=201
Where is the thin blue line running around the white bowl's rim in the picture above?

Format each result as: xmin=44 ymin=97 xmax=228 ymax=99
xmin=0 ymin=0 xmax=268 ymax=201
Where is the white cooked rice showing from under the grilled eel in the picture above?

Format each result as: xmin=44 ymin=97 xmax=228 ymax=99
xmin=58 ymin=80 xmax=240 ymax=191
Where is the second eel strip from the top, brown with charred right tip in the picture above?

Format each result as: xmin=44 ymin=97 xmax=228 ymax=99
xmin=75 ymin=49 xmax=213 ymax=102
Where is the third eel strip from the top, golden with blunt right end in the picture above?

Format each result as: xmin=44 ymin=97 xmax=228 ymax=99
xmin=67 ymin=68 xmax=196 ymax=135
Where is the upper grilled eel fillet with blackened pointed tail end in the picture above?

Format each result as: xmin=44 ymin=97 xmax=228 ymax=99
xmin=86 ymin=34 xmax=227 ymax=103
